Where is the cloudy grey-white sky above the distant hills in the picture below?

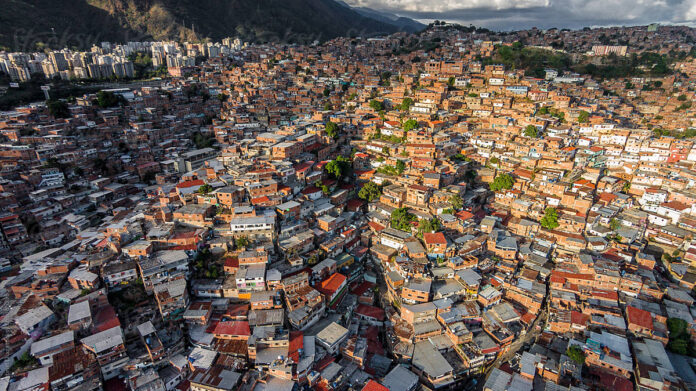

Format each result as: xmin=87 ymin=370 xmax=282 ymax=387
xmin=345 ymin=0 xmax=696 ymax=30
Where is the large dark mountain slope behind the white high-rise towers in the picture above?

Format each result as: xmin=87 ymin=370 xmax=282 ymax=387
xmin=0 ymin=0 xmax=399 ymax=50
